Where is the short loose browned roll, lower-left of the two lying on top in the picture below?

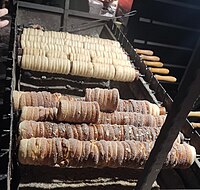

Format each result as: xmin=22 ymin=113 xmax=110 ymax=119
xmin=58 ymin=100 xmax=100 ymax=123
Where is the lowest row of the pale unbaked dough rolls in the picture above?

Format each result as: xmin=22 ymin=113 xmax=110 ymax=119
xmin=20 ymin=55 xmax=139 ymax=82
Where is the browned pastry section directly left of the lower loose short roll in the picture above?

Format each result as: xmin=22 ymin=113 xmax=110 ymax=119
xmin=20 ymin=106 xmax=57 ymax=121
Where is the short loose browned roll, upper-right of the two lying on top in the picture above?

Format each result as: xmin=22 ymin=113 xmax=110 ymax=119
xmin=85 ymin=88 xmax=119 ymax=112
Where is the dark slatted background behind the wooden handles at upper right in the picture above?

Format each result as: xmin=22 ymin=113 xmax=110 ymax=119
xmin=128 ymin=0 xmax=200 ymax=98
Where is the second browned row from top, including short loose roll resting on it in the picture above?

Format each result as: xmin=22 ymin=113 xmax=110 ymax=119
xmin=20 ymin=104 xmax=166 ymax=127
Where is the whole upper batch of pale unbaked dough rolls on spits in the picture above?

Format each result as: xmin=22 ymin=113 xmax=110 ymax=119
xmin=19 ymin=29 xmax=139 ymax=82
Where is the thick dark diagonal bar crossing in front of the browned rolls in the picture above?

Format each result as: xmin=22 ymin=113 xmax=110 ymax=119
xmin=136 ymin=38 xmax=200 ymax=190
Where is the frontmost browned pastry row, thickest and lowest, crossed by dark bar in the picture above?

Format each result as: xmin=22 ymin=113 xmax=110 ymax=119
xmin=18 ymin=138 xmax=196 ymax=169
